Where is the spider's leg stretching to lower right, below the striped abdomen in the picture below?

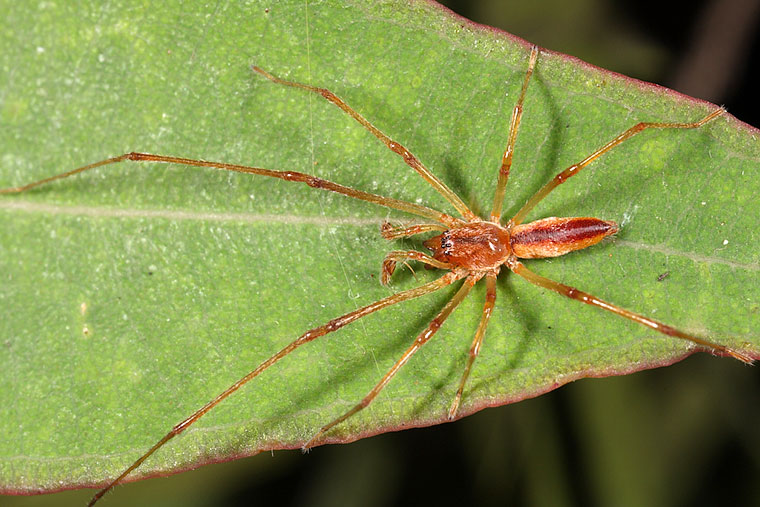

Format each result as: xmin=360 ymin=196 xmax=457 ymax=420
xmin=507 ymin=259 xmax=754 ymax=364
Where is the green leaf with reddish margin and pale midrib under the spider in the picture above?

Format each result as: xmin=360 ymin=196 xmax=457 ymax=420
xmin=0 ymin=2 xmax=760 ymax=498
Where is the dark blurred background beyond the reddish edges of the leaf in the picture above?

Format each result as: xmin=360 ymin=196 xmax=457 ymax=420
xmin=7 ymin=0 xmax=760 ymax=506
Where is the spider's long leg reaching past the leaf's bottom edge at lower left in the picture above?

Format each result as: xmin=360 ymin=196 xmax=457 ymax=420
xmin=89 ymin=271 xmax=465 ymax=506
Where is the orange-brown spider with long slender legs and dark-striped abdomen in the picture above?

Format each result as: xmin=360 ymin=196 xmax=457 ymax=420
xmin=0 ymin=46 xmax=753 ymax=505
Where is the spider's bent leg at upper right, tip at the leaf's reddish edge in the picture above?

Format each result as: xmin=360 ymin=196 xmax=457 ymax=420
xmin=509 ymin=107 xmax=726 ymax=225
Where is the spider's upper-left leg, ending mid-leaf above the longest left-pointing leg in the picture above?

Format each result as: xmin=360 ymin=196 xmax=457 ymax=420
xmin=252 ymin=66 xmax=476 ymax=221
